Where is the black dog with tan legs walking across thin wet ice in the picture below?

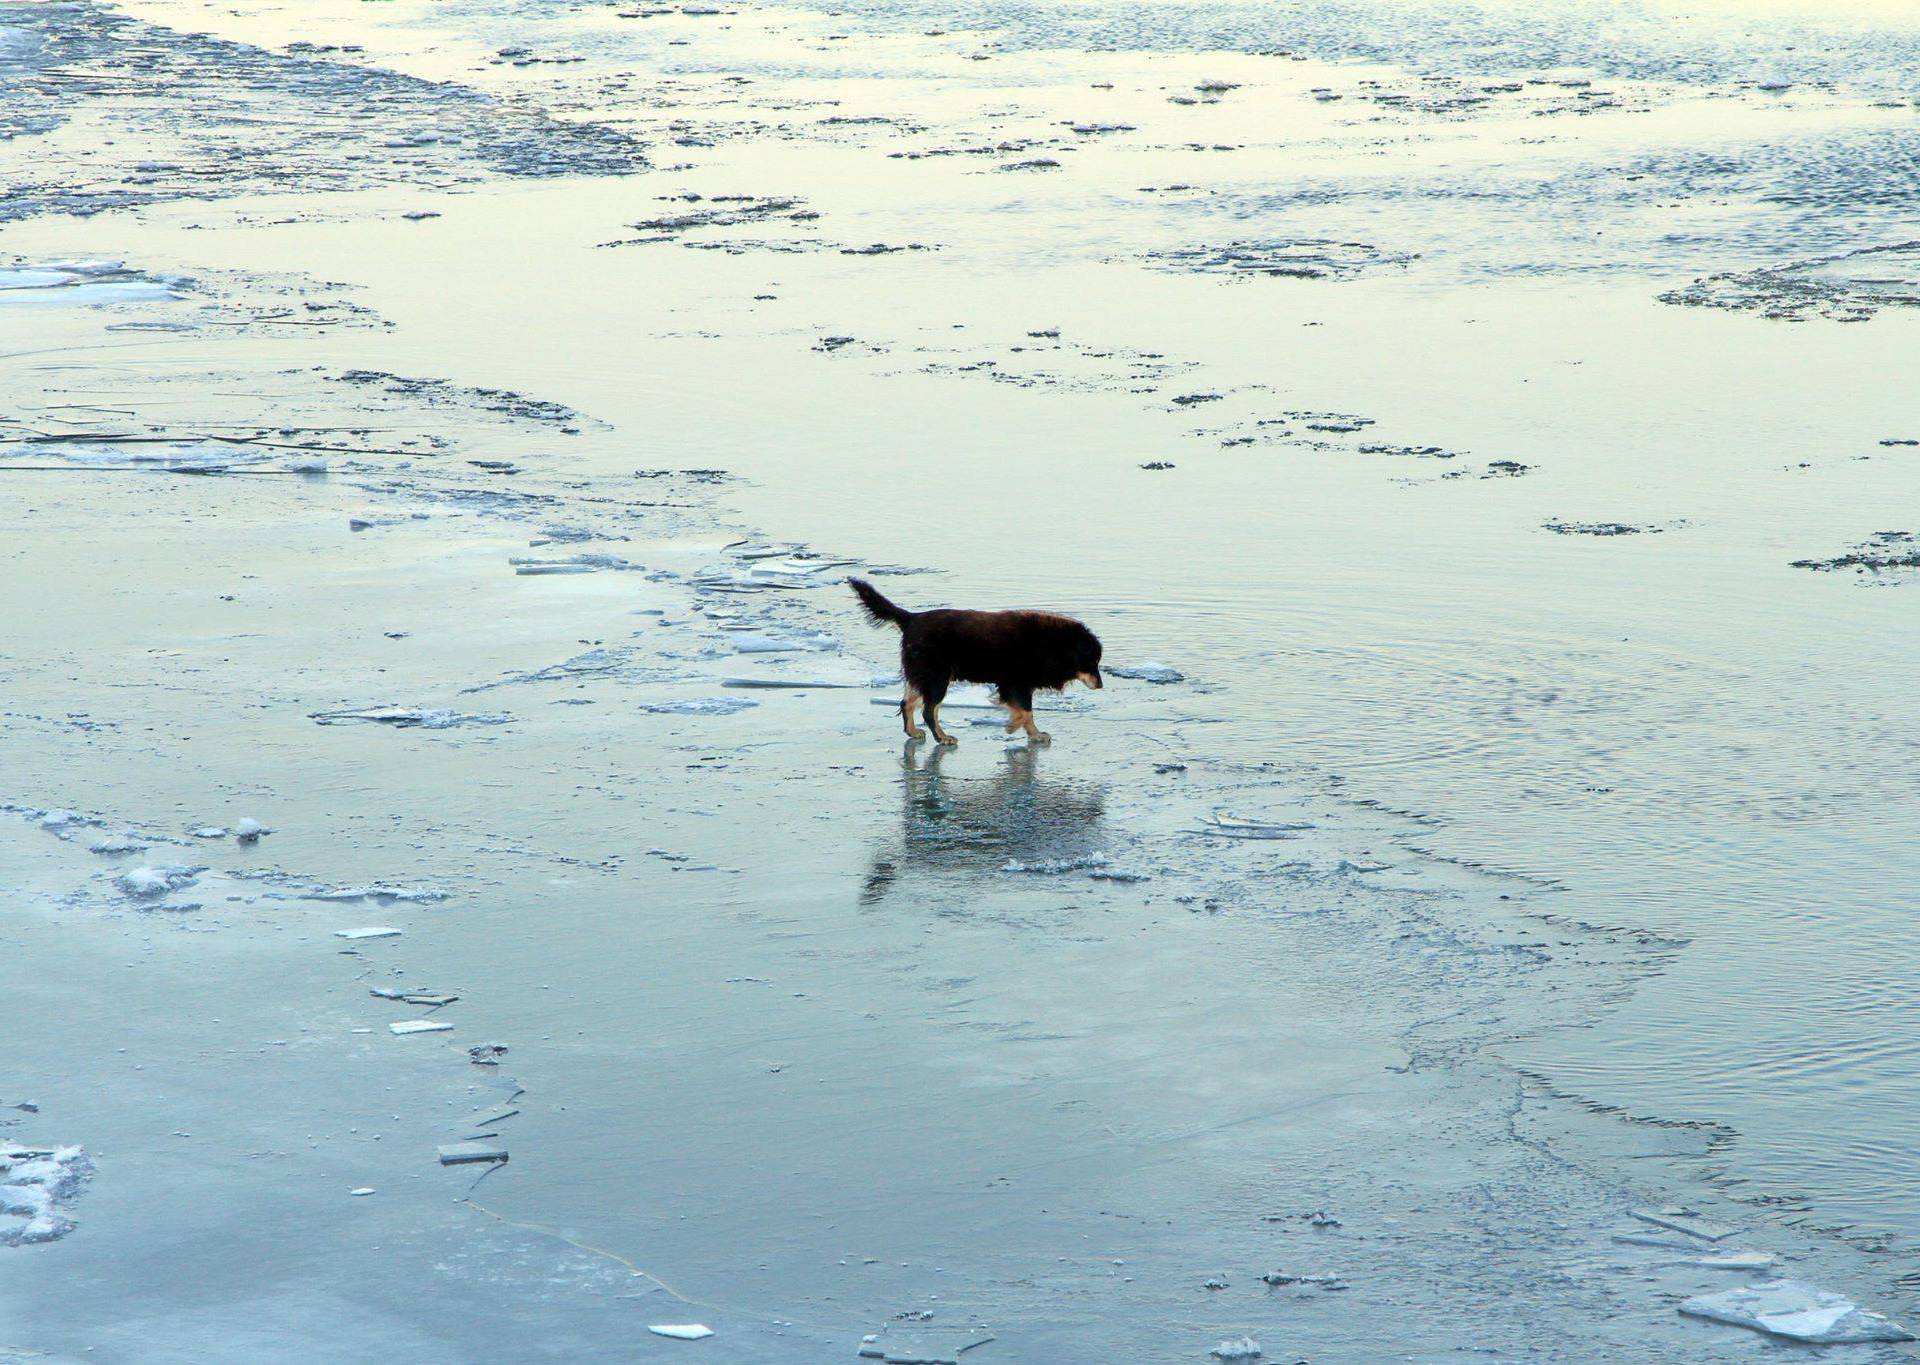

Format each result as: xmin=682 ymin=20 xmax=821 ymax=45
xmin=847 ymin=578 xmax=1102 ymax=745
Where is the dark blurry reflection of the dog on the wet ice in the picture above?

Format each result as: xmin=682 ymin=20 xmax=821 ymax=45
xmin=860 ymin=741 xmax=1106 ymax=904
